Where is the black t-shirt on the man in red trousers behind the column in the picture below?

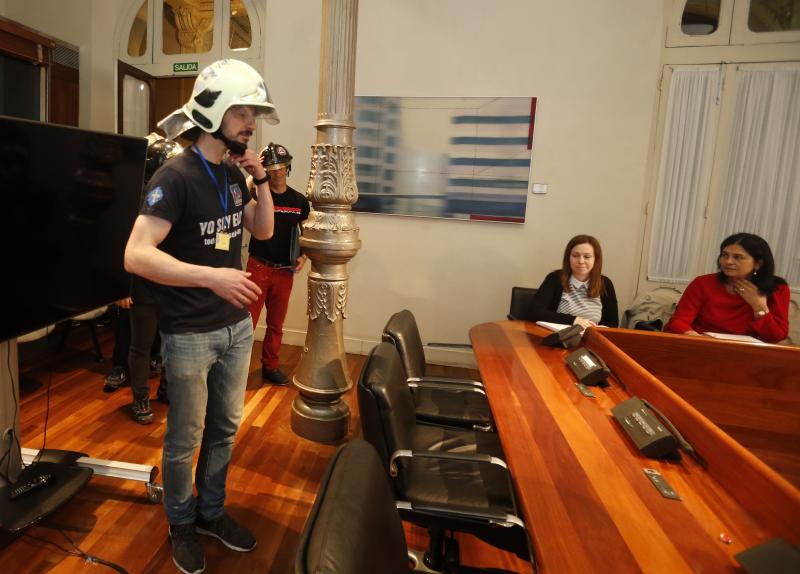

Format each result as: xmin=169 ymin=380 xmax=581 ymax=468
xmin=248 ymin=187 xmax=311 ymax=265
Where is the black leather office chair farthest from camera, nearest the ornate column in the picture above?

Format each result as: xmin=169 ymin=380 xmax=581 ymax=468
xmin=382 ymin=310 xmax=492 ymax=431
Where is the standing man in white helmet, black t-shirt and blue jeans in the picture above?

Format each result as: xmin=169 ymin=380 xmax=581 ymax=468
xmin=125 ymin=60 xmax=278 ymax=574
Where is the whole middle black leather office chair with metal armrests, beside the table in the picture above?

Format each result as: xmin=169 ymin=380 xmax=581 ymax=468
xmin=358 ymin=342 xmax=531 ymax=567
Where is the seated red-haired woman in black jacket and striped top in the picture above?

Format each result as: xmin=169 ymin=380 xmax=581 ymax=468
xmin=526 ymin=235 xmax=619 ymax=329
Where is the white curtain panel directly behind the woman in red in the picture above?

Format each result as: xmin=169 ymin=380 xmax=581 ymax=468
xmin=709 ymin=65 xmax=800 ymax=292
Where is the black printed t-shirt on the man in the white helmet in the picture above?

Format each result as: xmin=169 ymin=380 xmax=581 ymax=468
xmin=141 ymin=149 xmax=251 ymax=333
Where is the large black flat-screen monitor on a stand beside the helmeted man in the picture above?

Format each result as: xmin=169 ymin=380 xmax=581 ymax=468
xmin=0 ymin=116 xmax=147 ymax=341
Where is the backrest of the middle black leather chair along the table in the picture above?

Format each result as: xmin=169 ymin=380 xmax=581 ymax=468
xmin=358 ymin=341 xmax=417 ymax=469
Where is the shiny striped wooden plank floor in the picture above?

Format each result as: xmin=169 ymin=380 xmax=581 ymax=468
xmin=0 ymin=328 xmax=531 ymax=574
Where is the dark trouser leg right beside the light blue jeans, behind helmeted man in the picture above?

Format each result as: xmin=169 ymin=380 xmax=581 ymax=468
xmin=128 ymin=303 xmax=163 ymax=400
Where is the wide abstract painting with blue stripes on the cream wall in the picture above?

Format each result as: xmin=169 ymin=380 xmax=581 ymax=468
xmin=353 ymin=96 xmax=536 ymax=223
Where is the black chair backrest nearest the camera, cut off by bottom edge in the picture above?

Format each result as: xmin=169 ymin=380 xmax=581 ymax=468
xmin=295 ymin=438 xmax=409 ymax=574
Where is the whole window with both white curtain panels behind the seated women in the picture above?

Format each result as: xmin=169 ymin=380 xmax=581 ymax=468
xmin=644 ymin=62 xmax=800 ymax=293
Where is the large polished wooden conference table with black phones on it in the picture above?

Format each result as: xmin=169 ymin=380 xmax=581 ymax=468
xmin=470 ymin=321 xmax=800 ymax=574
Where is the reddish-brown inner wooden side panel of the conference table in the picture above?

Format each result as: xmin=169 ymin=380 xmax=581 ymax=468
xmin=597 ymin=329 xmax=800 ymax=488
